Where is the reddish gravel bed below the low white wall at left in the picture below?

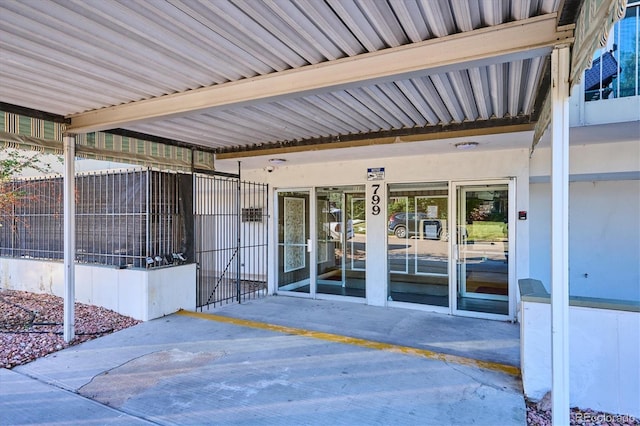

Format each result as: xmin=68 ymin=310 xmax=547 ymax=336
xmin=0 ymin=290 xmax=140 ymax=368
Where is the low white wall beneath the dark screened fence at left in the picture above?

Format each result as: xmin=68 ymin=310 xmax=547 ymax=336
xmin=0 ymin=258 xmax=196 ymax=321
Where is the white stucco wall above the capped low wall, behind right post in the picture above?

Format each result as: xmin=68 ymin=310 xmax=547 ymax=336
xmin=529 ymin=142 xmax=640 ymax=301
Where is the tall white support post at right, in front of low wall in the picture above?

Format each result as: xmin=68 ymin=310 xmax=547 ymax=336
xmin=551 ymin=46 xmax=570 ymax=425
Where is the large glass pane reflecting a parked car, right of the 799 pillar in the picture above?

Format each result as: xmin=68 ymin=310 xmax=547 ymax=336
xmin=387 ymin=182 xmax=449 ymax=307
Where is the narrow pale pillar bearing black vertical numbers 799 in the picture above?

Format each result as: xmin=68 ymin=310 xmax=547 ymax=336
xmin=365 ymin=180 xmax=388 ymax=306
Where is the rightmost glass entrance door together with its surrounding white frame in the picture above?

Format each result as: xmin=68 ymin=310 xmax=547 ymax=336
xmin=450 ymin=179 xmax=515 ymax=319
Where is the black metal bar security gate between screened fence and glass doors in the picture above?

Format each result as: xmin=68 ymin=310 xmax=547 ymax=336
xmin=193 ymin=174 xmax=269 ymax=310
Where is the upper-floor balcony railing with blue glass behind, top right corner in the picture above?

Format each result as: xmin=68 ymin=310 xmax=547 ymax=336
xmin=584 ymin=2 xmax=640 ymax=101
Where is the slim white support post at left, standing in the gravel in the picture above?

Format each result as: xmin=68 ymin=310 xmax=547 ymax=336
xmin=63 ymin=135 xmax=76 ymax=343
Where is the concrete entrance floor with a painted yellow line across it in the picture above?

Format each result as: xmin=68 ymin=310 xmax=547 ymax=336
xmin=0 ymin=296 xmax=526 ymax=425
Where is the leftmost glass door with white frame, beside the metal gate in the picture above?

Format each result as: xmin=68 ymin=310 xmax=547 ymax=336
xmin=277 ymin=191 xmax=310 ymax=294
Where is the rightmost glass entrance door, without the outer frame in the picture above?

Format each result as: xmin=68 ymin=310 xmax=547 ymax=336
xmin=452 ymin=181 xmax=512 ymax=315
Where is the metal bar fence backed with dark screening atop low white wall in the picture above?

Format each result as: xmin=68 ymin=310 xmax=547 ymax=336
xmin=0 ymin=169 xmax=193 ymax=268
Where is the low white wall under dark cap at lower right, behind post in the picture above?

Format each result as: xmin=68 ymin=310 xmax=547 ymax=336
xmin=520 ymin=302 xmax=640 ymax=418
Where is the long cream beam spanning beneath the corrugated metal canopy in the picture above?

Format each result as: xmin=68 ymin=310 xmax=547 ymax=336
xmin=67 ymin=13 xmax=573 ymax=133
